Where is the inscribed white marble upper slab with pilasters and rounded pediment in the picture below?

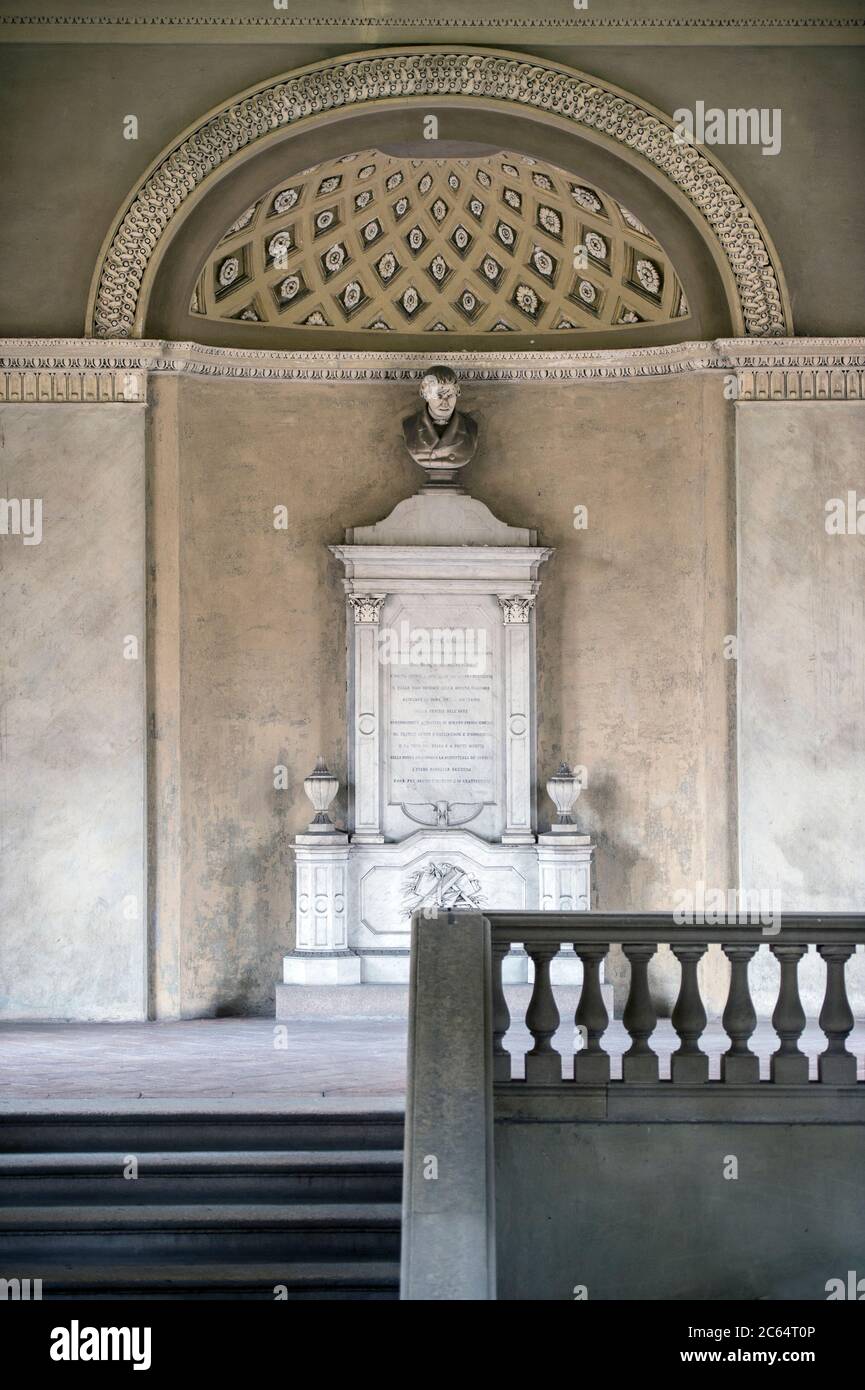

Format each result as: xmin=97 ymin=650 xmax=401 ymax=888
xmin=331 ymin=492 xmax=551 ymax=842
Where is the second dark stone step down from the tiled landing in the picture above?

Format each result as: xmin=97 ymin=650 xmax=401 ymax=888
xmin=0 ymin=1150 xmax=402 ymax=1207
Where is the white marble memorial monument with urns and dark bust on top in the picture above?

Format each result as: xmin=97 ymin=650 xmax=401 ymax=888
xmin=277 ymin=367 xmax=594 ymax=1016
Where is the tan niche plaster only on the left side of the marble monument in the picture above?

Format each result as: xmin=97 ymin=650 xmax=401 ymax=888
xmin=150 ymin=381 xmax=422 ymax=1016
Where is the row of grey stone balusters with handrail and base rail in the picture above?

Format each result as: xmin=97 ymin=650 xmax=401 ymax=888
xmin=485 ymin=912 xmax=865 ymax=1086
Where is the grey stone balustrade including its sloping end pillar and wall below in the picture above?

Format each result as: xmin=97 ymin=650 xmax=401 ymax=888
xmin=402 ymin=912 xmax=865 ymax=1301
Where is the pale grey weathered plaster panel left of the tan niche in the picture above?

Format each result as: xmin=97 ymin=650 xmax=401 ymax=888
xmin=0 ymin=404 xmax=146 ymax=1019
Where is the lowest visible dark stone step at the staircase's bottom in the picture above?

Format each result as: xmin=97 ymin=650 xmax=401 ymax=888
xmin=11 ymin=1255 xmax=399 ymax=1302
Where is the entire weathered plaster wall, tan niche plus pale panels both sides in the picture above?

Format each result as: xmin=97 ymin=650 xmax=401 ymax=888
xmin=0 ymin=375 xmax=865 ymax=1017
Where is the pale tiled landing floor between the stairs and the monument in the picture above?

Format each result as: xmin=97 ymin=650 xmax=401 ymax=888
xmin=0 ymin=1019 xmax=865 ymax=1102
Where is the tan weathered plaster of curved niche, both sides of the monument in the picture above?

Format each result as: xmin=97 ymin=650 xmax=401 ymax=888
xmin=150 ymin=377 xmax=734 ymax=1015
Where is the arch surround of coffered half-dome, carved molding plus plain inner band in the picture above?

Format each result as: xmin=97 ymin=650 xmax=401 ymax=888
xmin=88 ymin=47 xmax=793 ymax=350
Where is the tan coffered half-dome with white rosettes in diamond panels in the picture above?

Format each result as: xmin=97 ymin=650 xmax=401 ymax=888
xmin=189 ymin=150 xmax=688 ymax=342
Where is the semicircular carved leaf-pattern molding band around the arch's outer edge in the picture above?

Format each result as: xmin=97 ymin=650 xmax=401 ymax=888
xmin=86 ymin=46 xmax=793 ymax=338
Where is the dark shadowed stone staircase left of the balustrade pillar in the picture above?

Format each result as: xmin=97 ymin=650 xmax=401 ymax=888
xmin=0 ymin=1099 xmax=403 ymax=1301
